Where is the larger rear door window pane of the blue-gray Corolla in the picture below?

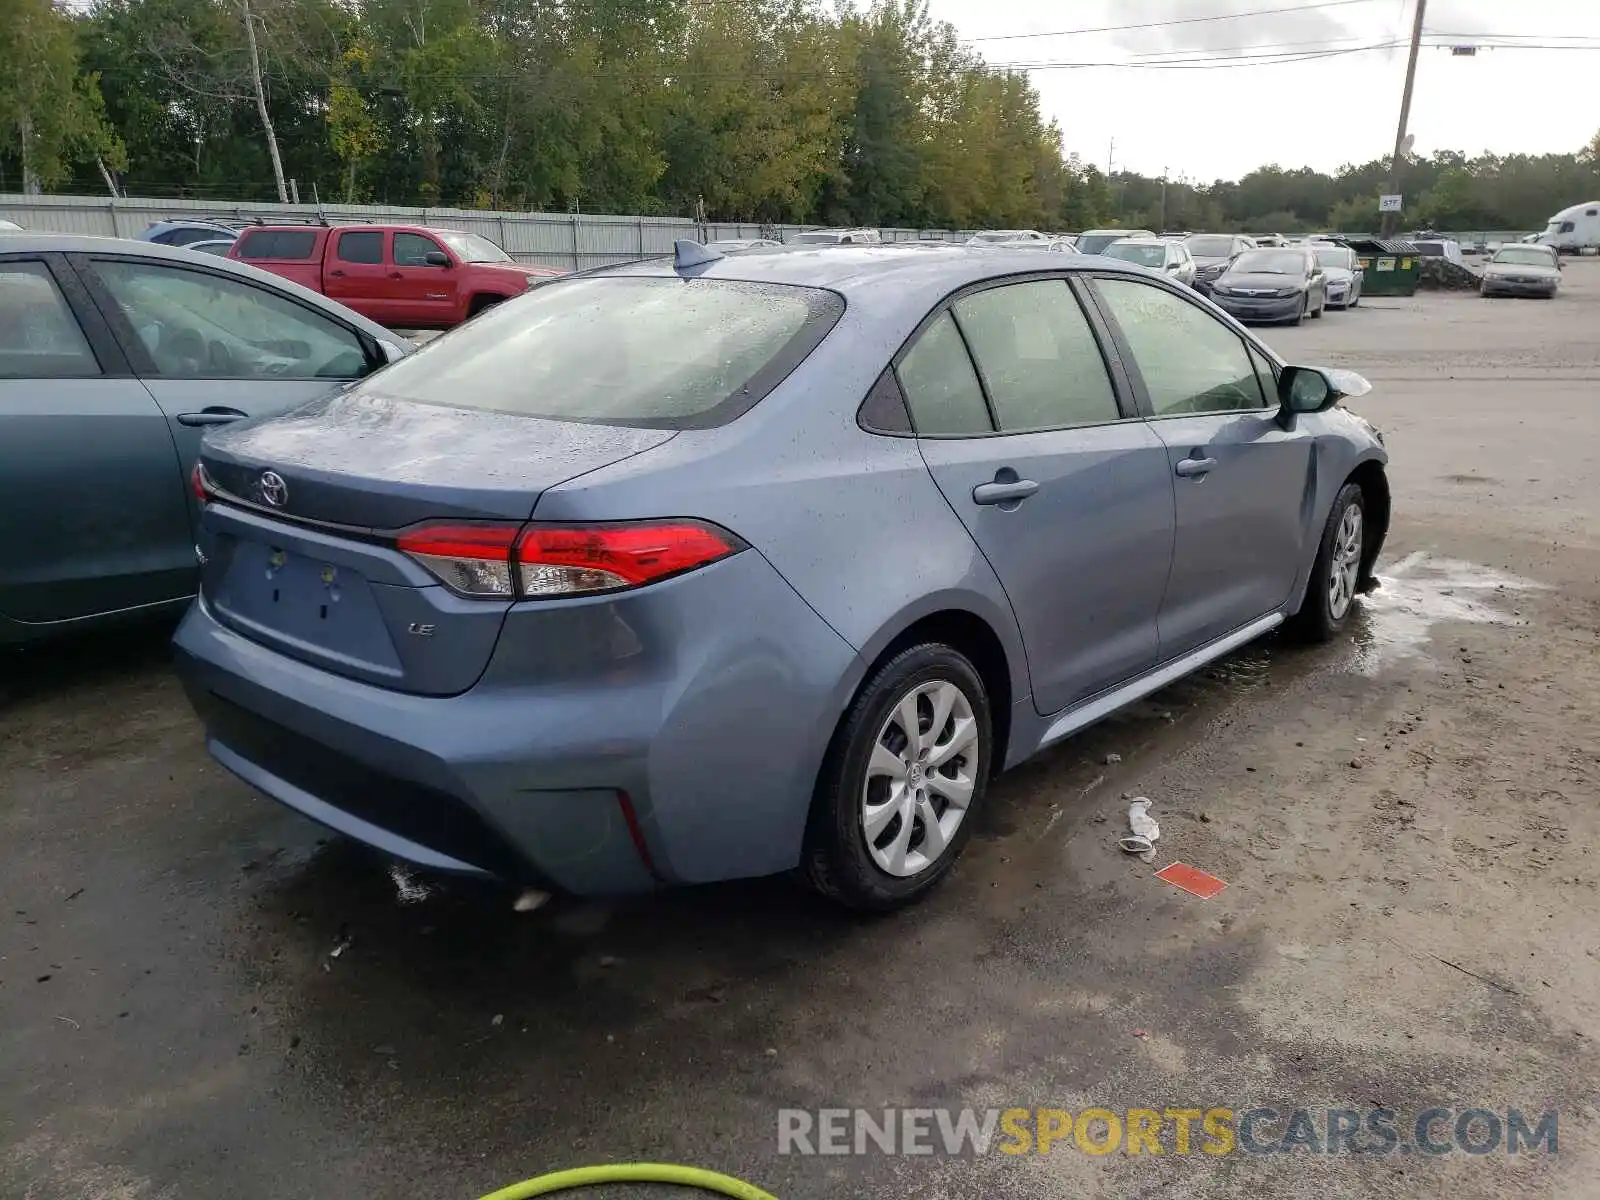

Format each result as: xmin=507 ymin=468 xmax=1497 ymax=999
xmin=955 ymin=280 xmax=1122 ymax=434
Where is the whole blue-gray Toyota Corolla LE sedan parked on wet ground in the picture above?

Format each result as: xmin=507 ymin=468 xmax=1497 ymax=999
xmin=176 ymin=243 xmax=1389 ymax=909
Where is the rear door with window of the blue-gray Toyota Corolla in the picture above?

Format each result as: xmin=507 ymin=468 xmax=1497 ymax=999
xmin=896 ymin=278 xmax=1173 ymax=714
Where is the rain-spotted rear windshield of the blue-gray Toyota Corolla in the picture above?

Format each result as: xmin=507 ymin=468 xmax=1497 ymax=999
xmin=362 ymin=277 xmax=845 ymax=429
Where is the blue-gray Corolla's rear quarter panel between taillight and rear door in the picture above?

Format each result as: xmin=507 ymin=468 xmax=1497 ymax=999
xmin=533 ymin=310 xmax=1030 ymax=713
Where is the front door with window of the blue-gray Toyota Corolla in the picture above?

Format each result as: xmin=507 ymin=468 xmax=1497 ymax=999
xmin=1094 ymin=277 xmax=1314 ymax=659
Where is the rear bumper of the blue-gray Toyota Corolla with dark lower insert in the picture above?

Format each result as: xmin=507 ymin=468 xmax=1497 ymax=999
xmin=174 ymin=550 xmax=861 ymax=894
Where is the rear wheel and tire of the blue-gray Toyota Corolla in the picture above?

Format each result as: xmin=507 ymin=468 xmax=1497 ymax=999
xmin=803 ymin=643 xmax=994 ymax=912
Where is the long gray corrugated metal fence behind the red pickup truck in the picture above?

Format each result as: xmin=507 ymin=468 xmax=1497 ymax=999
xmin=0 ymin=194 xmax=965 ymax=270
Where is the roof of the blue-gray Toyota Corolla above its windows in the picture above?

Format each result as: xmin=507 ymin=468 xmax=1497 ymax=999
xmin=588 ymin=242 xmax=1150 ymax=320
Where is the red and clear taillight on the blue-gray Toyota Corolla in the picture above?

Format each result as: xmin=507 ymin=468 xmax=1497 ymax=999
xmin=395 ymin=522 xmax=744 ymax=600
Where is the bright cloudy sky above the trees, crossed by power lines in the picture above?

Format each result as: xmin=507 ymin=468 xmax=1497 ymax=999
xmin=930 ymin=0 xmax=1600 ymax=182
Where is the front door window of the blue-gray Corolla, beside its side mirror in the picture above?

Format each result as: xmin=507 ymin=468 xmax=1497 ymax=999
xmin=1094 ymin=278 xmax=1267 ymax=416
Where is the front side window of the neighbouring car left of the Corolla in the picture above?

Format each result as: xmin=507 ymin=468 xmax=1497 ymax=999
xmin=94 ymin=261 xmax=370 ymax=379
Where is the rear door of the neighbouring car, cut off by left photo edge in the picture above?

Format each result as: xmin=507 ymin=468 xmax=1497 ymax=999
xmin=0 ymin=253 xmax=195 ymax=624
